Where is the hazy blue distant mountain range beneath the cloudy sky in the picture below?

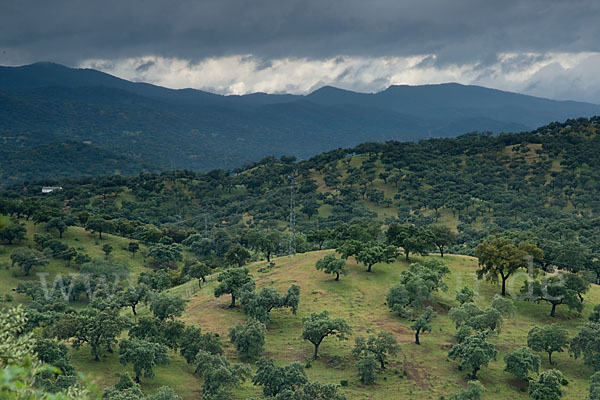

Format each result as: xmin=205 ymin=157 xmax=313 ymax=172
xmin=0 ymin=63 xmax=600 ymax=184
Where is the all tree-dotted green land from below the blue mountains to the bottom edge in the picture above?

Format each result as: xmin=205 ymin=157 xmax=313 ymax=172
xmin=0 ymin=117 xmax=600 ymax=400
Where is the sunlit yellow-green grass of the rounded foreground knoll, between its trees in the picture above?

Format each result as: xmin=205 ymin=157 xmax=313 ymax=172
xmin=184 ymin=251 xmax=600 ymax=399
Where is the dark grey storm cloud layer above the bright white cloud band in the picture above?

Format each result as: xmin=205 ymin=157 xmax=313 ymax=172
xmin=0 ymin=0 xmax=600 ymax=66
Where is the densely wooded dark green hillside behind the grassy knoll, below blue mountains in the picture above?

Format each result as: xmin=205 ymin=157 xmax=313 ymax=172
xmin=6 ymin=118 xmax=600 ymax=254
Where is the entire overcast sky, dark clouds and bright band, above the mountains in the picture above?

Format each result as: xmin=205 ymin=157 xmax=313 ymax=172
xmin=0 ymin=0 xmax=600 ymax=104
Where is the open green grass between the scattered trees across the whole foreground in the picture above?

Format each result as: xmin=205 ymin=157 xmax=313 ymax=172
xmin=0 ymin=223 xmax=600 ymax=399
